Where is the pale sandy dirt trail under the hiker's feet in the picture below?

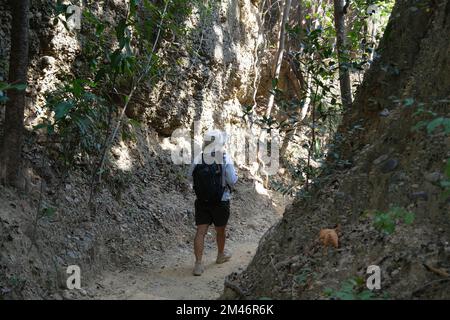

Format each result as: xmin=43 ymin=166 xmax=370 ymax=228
xmin=90 ymin=182 xmax=285 ymax=300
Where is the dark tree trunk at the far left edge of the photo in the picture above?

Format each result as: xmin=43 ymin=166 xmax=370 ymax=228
xmin=1 ymin=0 xmax=30 ymax=186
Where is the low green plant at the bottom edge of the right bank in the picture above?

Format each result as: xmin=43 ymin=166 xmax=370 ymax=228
xmin=324 ymin=278 xmax=374 ymax=300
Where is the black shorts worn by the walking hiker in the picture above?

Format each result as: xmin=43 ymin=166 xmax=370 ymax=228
xmin=195 ymin=200 xmax=230 ymax=227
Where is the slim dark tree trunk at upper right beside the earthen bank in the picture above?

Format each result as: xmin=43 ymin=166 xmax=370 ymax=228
xmin=334 ymin=0 xmax=352 ymax=109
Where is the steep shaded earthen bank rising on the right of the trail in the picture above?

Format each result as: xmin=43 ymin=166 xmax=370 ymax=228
xmin=229 ymin=0 xmax=450 ymax=300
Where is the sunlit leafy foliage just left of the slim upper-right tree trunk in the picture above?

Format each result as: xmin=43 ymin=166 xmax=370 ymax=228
xmin=272 ymin=21 xmax=342 ymax=196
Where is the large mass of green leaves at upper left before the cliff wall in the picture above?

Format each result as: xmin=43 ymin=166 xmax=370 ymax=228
xmin=36 ymin=0 xmax=200 ymax=172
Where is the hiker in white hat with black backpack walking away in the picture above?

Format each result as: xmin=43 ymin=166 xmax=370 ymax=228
xmin=189 ymin=130 xmax=238 ymax=276
